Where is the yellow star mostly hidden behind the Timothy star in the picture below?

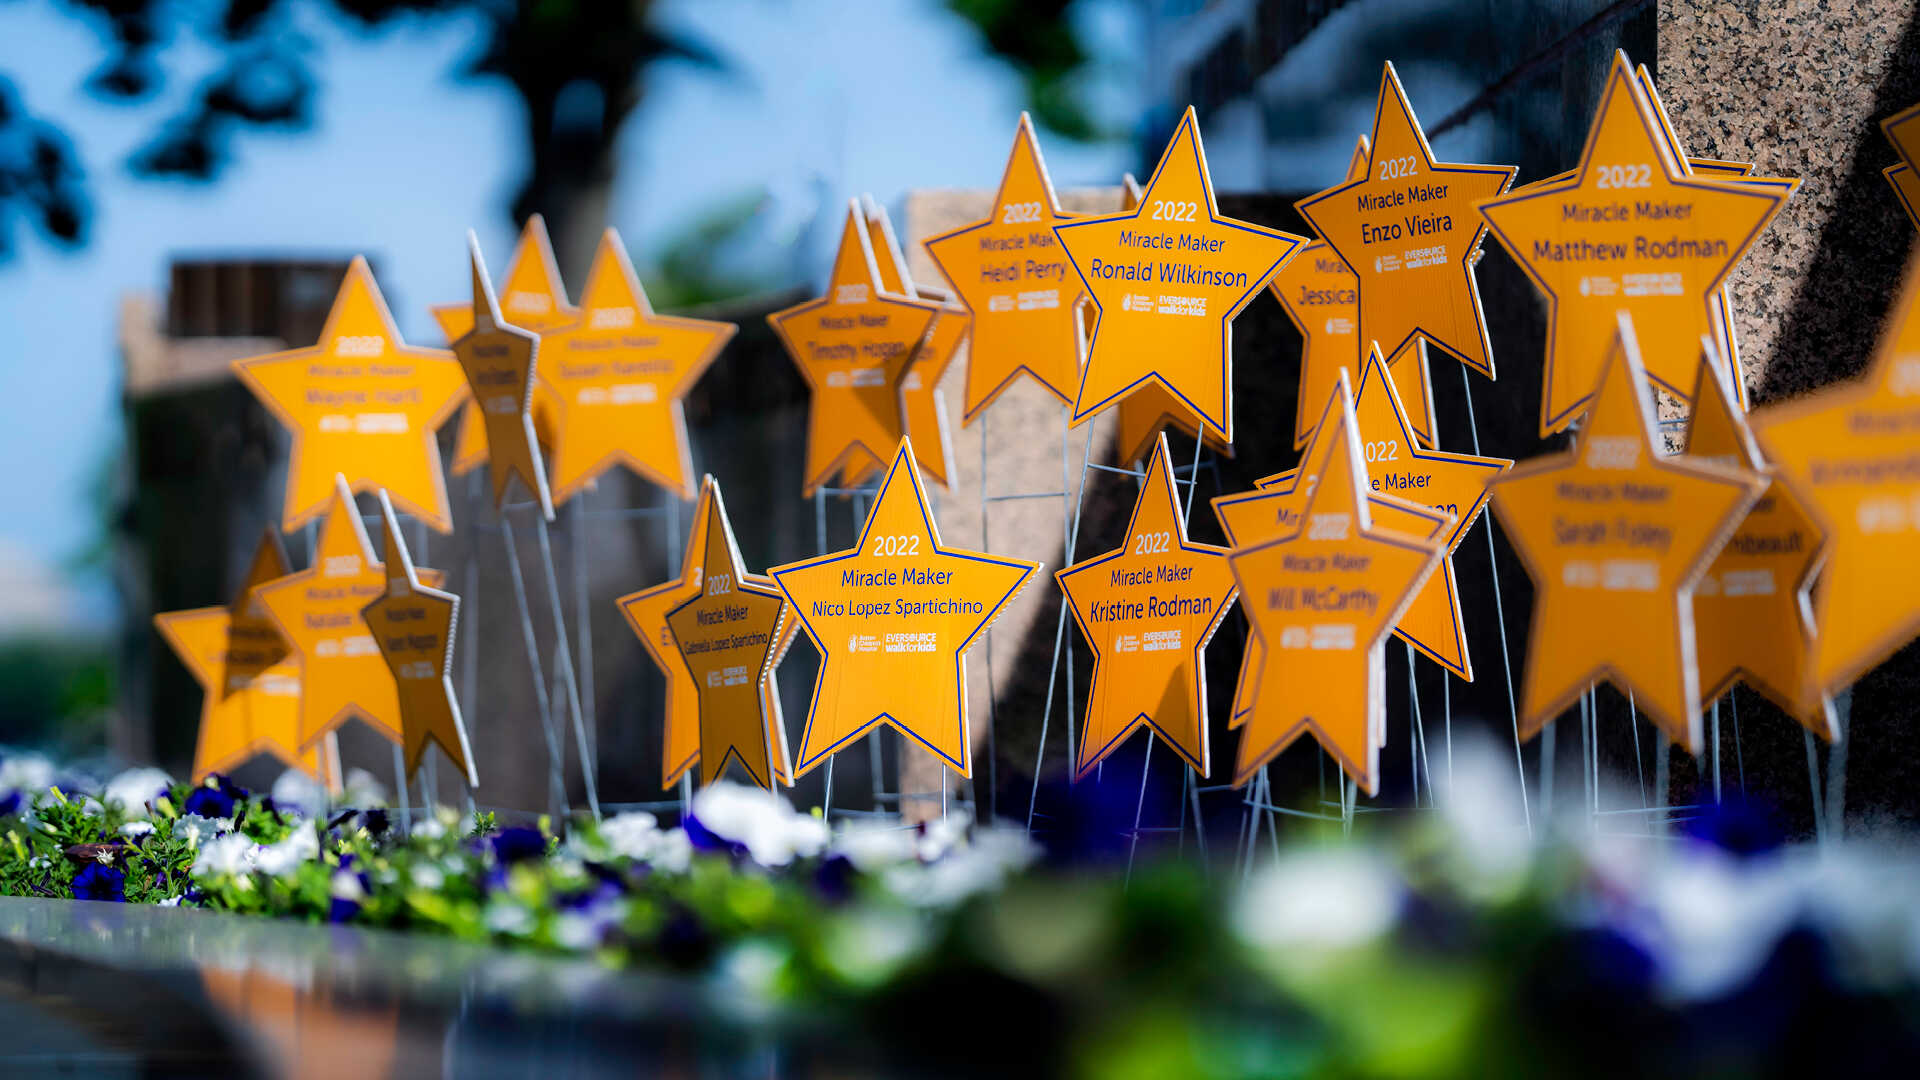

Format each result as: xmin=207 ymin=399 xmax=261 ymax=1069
xmin=864 ymin=196 xmax=973 ymax=488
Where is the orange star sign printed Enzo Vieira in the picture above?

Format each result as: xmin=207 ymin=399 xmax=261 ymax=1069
xmin=1298 ymin=63 xmax=1515 ymax=379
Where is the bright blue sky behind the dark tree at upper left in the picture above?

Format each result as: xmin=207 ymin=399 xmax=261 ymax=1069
xmin=0 ymin=0 xmax=1139 ymax=630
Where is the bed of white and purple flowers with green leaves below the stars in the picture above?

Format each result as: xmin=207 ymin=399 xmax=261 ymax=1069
xmin=0 ymin=749 xmax=1920 ymax=1076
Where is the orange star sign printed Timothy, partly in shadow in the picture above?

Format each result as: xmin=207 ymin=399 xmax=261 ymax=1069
xmin=766 ymin=200 xmax=939 ymax=494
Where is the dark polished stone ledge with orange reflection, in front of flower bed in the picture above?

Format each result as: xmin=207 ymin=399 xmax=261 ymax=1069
xmin=0 ymin=899 xmax=872 ymax=1076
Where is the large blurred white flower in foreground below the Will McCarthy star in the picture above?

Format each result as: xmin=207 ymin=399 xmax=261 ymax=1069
xmin=1233 ymin=849 xmax=1402 ymax=949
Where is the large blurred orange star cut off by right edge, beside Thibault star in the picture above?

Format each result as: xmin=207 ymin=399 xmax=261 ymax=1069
xmin=1753 ymin=255 xmax=1920 ymax=694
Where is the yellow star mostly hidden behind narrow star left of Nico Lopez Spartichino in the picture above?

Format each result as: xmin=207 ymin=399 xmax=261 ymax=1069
xmin=618 ymin=477 xmax=801 ymax=790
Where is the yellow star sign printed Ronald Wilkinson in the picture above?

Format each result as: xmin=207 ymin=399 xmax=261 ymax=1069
xmin=1054 ymin=108 xmax=1302 ymax=442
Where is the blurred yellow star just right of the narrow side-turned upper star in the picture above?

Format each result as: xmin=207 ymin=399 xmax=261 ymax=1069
xmin=540 ymin=229 xmax=739 ymax=503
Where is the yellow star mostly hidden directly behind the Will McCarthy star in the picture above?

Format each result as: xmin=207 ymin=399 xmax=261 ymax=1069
xmin=1213 ymin=369 xmax=1465 ymax=726
